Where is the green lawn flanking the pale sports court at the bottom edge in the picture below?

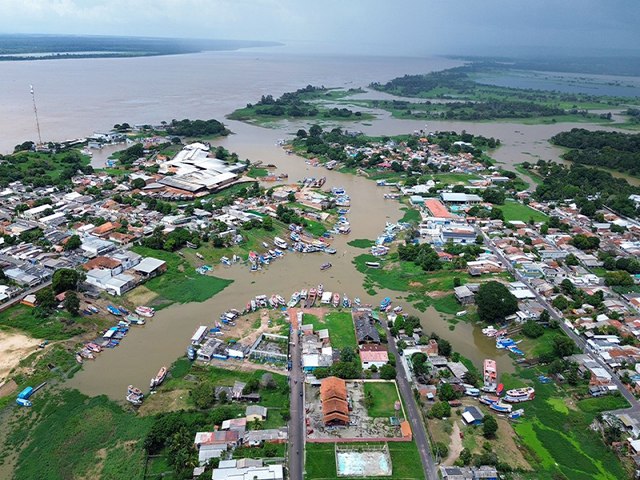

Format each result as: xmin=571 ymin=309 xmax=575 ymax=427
xmin=305 ymin=442 xmax=424 ymax=480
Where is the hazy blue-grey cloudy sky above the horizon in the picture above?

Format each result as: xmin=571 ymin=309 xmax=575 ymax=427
xmin=0 ymin=0 xmax=640 ymax=56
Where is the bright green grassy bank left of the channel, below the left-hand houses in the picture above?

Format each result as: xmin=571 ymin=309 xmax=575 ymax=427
xmin=132 ymin=246 xmax=232 ymax=305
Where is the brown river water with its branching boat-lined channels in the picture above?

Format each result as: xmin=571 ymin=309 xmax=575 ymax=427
xmin=0 ymin=50 xmax=636 ymax=399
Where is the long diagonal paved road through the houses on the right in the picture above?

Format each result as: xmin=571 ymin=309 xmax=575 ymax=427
xmin=478 ymin=230 xmax=640 ymax=414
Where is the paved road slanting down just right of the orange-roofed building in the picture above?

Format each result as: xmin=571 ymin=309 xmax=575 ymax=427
xmin=385 ymin=325 xmax=438 ymax=480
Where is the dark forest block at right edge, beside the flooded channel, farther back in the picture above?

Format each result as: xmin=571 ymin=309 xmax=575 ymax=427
xmin=551 ymin=128 xmax=640 ymax=175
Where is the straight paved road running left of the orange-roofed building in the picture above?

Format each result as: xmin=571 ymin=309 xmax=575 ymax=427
xmin=289 ymin=320 xmax=305 ymax=480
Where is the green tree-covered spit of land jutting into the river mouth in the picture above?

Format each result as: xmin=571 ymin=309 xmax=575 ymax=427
xmin=229 ymin=85 xmax=363 ymax=120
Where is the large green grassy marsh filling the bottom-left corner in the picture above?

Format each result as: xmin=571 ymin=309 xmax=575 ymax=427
xmin=3 ymin=390 xmax=152 ymax=480
